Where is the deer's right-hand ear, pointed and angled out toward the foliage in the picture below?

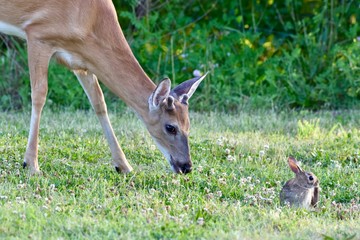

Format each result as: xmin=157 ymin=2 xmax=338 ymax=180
xmin=170 ymin=72 xmax=209 ymax=105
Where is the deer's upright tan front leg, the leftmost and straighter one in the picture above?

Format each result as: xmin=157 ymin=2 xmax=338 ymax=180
xmin=23 ymin=39 xmax=53 ymax=174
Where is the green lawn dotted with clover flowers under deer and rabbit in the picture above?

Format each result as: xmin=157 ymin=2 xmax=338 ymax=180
xmin=0 ymin=111 xmax=360 ymax=239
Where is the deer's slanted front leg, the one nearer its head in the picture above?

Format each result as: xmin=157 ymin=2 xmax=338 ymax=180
xmin=74 ymin=70 xmax=132 ymax=173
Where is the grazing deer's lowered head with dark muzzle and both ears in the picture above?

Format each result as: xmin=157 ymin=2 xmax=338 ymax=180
xmin=145 ymin=74 xmax=206 ymax=173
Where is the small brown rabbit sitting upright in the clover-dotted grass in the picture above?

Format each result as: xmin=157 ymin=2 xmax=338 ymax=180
xmin=280 ymin=157 xmax=319 ymax=209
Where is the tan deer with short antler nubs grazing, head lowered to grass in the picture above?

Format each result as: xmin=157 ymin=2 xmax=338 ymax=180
xmin=0 ymin=0 xmax=206 ymax=174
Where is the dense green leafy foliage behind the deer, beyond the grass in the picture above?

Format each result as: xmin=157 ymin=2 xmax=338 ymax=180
xmin=0 ymin=0 xmax=360 ymax=111
